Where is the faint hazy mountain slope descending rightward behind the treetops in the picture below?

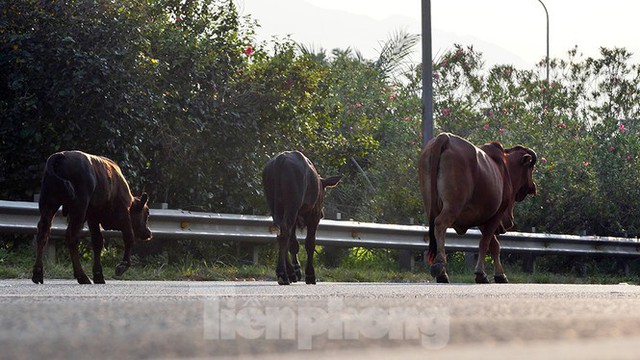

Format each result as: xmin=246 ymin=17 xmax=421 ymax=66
xmin=239 ymin=0 xmax=532 ymax=69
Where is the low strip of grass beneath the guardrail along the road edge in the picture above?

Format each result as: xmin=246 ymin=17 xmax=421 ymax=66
xmin=0 ymin=241 xmax=640 ymax=284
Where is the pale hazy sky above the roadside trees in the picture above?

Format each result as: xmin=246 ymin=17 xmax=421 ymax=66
xmin=236 ymin=0 xmax=640 ymax=69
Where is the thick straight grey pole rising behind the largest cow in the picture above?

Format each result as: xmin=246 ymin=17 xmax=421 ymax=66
xmin=422 ymin=0 xmax=433 ymax=147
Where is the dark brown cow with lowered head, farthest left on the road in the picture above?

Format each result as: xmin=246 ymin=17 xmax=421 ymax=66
xmin=31 ymin=151 xmax=151 ymax=284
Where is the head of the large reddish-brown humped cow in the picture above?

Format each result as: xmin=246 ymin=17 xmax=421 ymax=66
xmin=505 ymin=145 xmax=538 ymax=202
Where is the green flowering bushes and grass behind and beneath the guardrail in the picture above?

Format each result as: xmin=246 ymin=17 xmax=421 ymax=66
xmin=0 ymin=0 xmax=640 ymax=282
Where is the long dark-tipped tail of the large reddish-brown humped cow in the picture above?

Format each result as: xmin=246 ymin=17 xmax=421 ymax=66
xmin=420 ymin=135 xmax=449 ymax=264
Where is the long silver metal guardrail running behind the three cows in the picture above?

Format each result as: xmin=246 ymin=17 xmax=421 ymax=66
xmin=0 ymin=200 xmax=640 ymax=257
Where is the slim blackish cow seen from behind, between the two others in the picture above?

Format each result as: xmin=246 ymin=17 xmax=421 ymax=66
xmin=262 ymin=151 xmax=342 ymax=285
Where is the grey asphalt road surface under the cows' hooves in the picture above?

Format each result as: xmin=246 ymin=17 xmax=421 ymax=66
xmin=0 ymin=279 xmax=640 ymax=360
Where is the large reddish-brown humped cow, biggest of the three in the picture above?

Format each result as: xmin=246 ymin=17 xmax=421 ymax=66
xmin=419 ymin=133 xmax=537 ymax=283
